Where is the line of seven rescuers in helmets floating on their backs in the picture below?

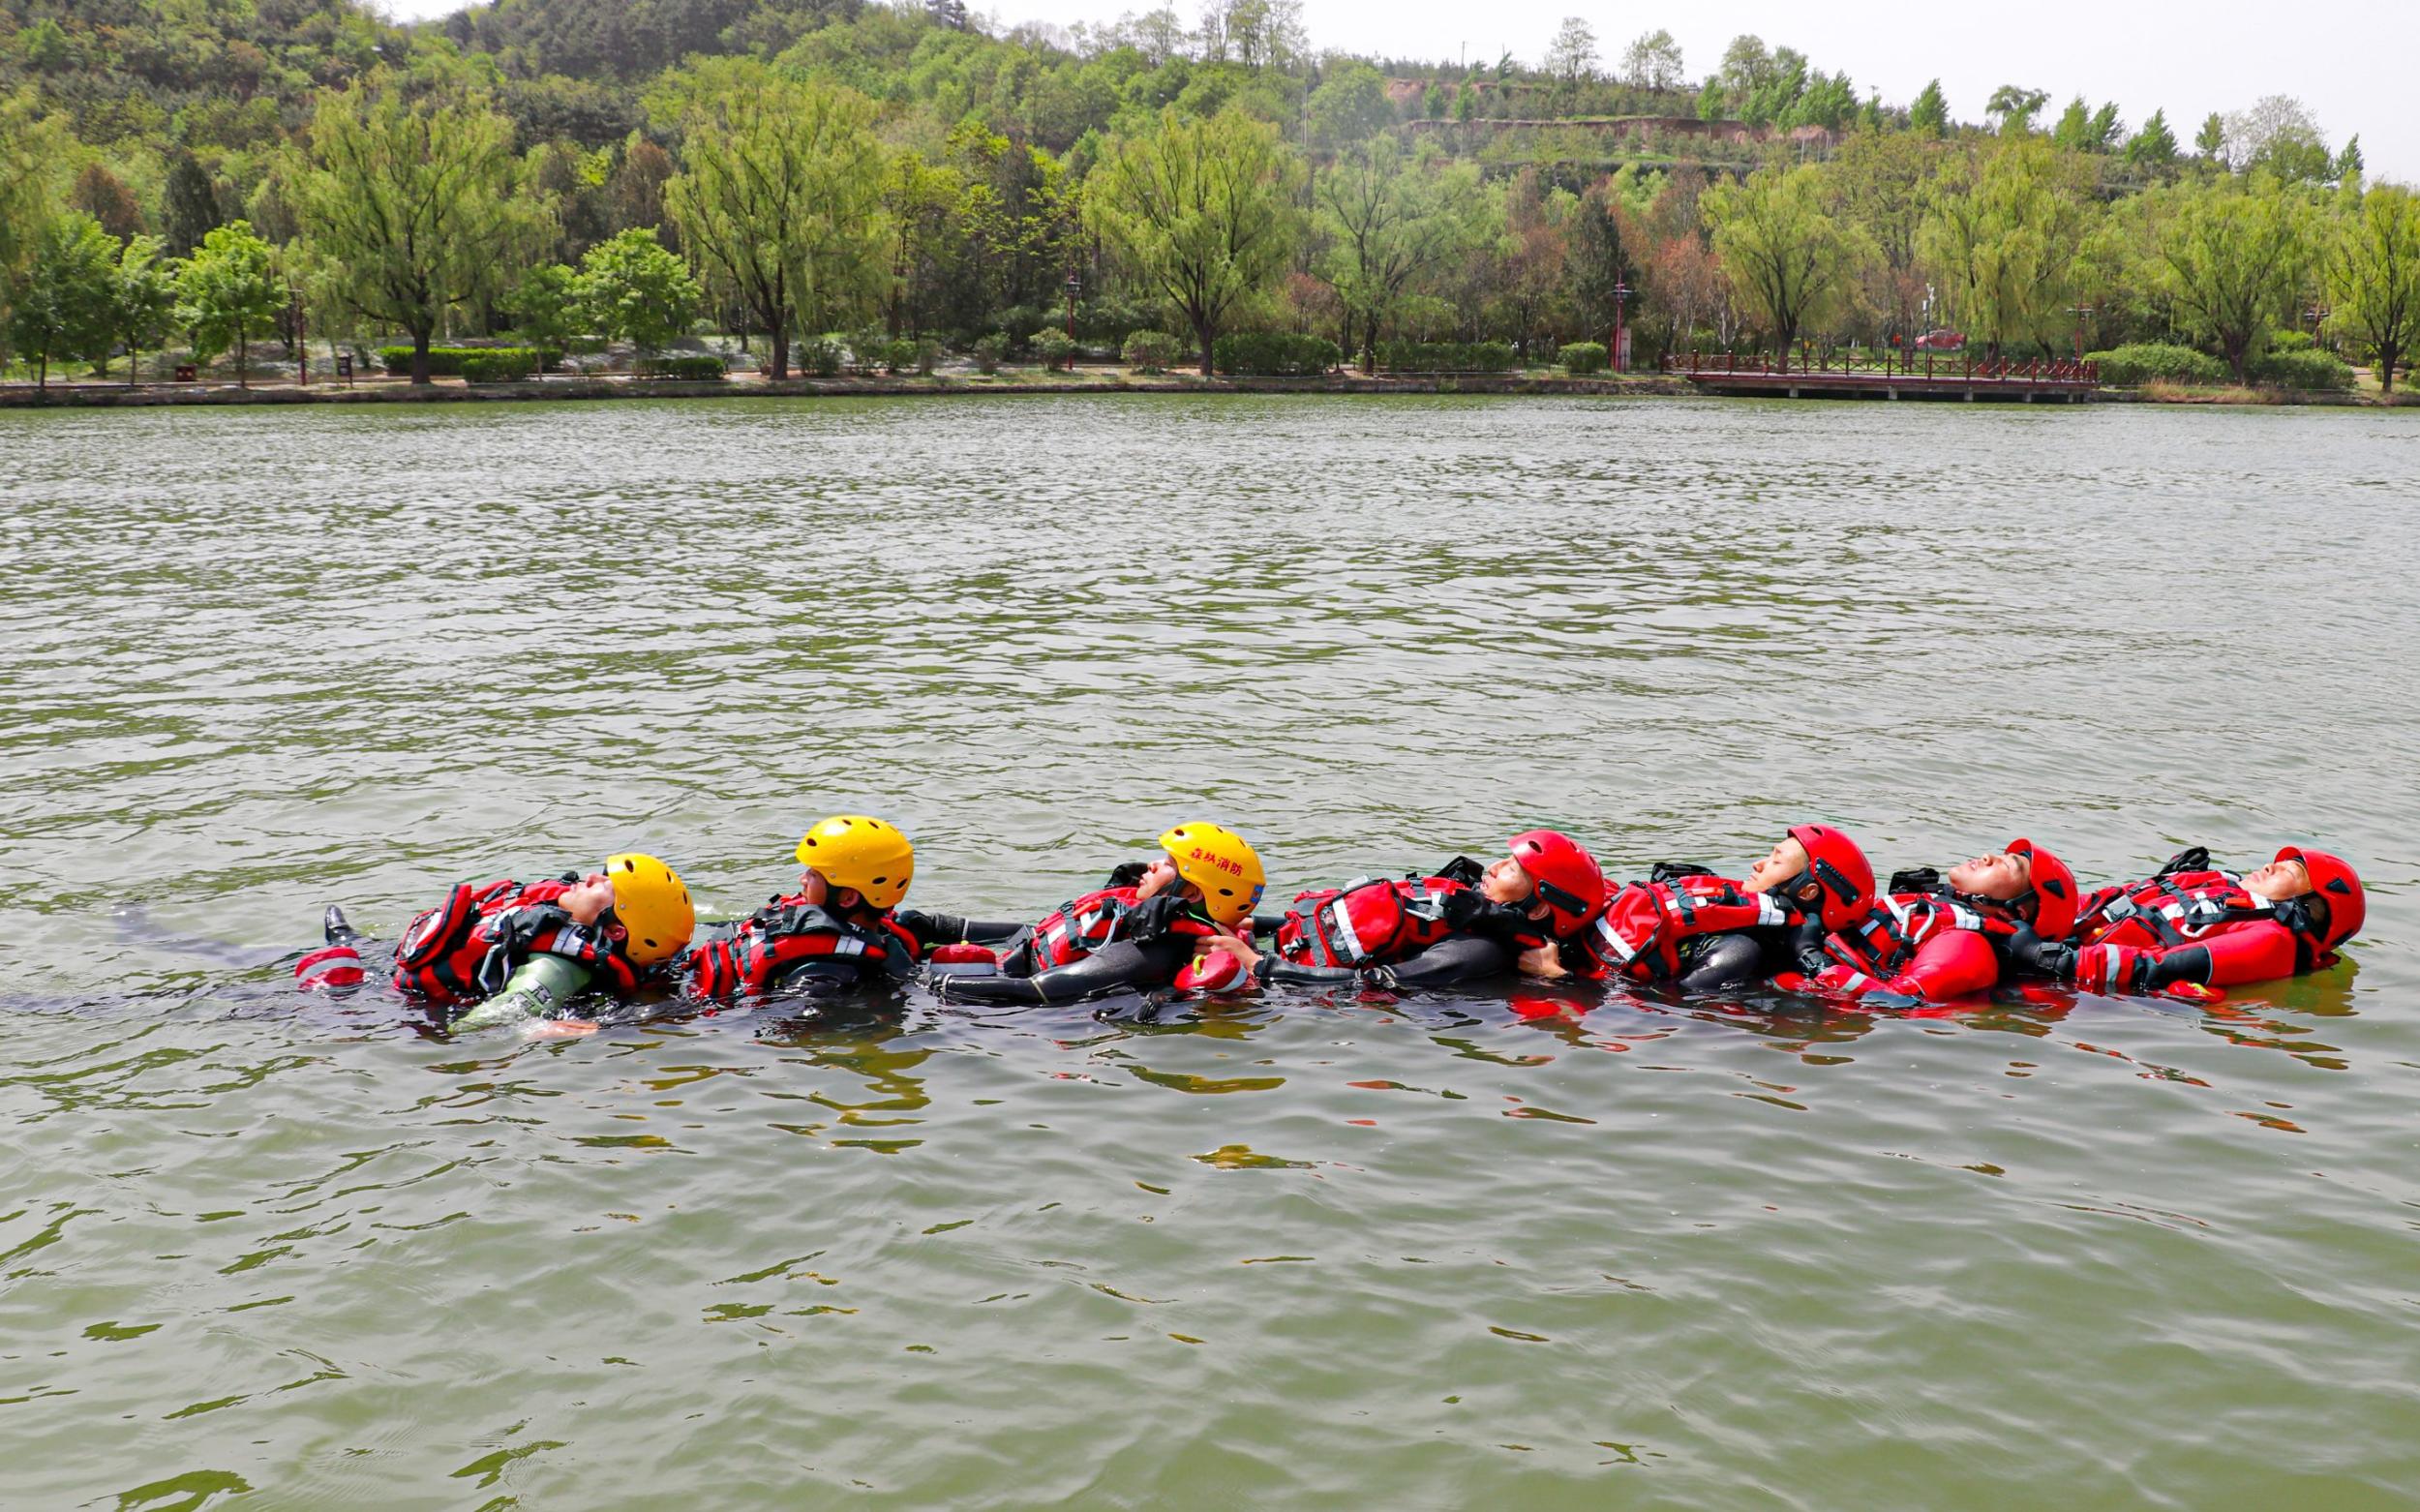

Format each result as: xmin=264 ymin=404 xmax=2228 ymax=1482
xmin=295 ymin=815 xmax=2365 ymax=1028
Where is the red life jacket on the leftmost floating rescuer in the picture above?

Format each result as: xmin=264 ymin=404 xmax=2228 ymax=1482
xmin=395 ymin=878 xmax=639 ymax=1004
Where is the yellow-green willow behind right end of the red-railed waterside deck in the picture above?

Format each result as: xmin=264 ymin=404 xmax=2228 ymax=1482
xmin=1917 ymin=136 xmax=2091 ymax=355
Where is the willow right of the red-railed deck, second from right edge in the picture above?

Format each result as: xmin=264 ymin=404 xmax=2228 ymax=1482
xmin=2159 ymin=174 xmax=2309 ymax=382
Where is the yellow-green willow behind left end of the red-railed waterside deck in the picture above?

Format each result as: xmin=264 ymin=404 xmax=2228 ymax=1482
xmin=1699 ymin=165 xmax=1871 ymax=353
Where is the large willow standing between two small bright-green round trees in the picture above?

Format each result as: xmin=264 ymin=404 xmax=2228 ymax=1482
xmin=293 ymin=70 xmax=545 ymax=382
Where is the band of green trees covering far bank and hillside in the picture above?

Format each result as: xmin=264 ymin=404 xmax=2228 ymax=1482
xmin=0 ymin=0 xmax=2420 ymax=384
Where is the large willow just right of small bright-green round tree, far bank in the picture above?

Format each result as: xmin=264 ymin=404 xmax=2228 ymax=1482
xmin=651 ymin=58 xmax=891 ymax=378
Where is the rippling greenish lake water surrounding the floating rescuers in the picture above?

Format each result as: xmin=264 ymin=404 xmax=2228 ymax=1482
xmin=0 ymin=397 xmax=2420 ymax=1512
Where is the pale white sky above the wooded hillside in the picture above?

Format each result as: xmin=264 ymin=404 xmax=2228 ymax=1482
xmin=387 ymin=0 xmax=2420 ymax=181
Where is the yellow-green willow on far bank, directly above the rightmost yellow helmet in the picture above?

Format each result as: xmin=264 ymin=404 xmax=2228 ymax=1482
xmin=1084 ymin=106 xmax=1302 ymax=378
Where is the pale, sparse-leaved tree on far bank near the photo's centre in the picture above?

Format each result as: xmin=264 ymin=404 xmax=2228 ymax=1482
xmin=1315 ymin=136 xmax=1479 ymax=373
